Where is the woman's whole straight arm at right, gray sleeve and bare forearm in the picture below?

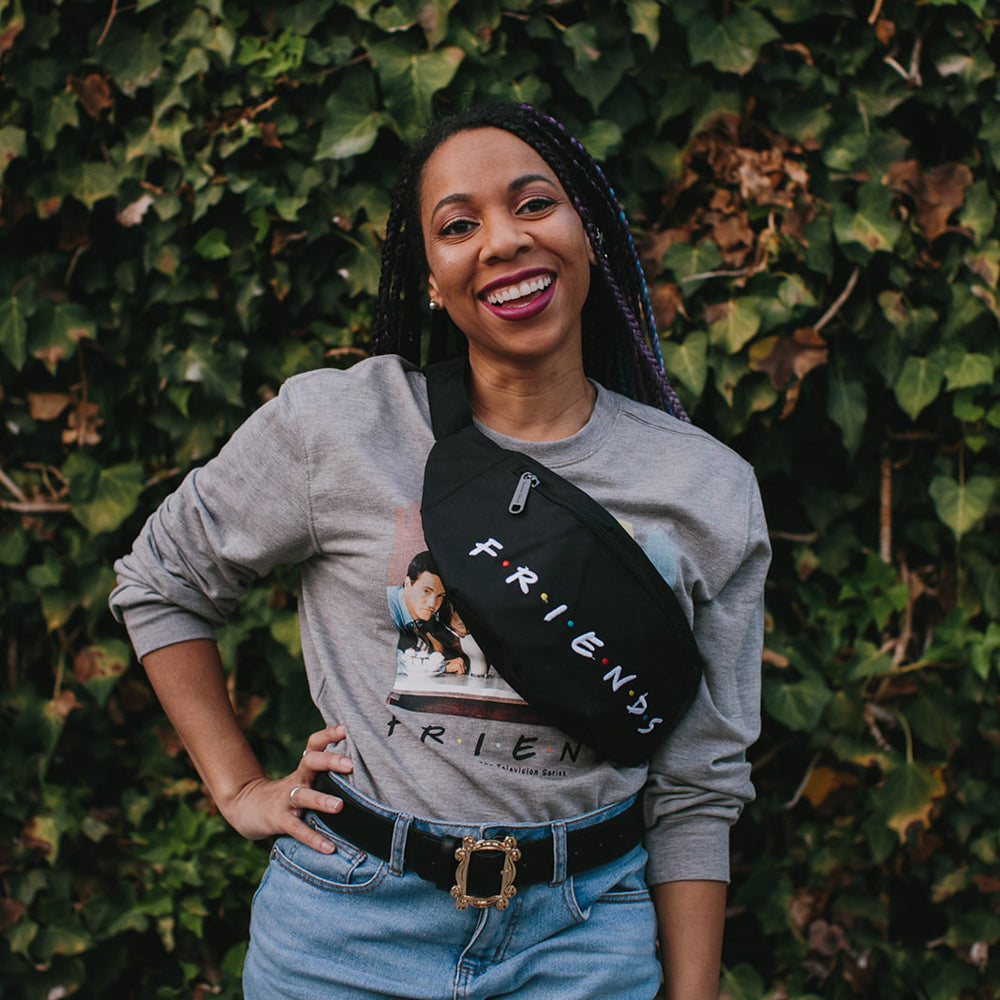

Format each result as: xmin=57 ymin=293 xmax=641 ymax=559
xmin=646 ymin=482 xmax=770 ymax=1000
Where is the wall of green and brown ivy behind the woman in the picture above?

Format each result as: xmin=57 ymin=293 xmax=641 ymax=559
xmin=0 ymin=0 xmax=1000 ymax=1000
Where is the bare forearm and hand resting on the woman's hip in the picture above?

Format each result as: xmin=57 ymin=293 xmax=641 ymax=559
xmin=142 ymin=639 xmax=351 ymax=854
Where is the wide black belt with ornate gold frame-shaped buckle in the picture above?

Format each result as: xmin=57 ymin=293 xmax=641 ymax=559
xmin=314 ymin=774 xmax=642 ymax=910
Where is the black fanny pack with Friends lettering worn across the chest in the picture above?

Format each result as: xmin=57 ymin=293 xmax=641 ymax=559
xmin=421 ymin=359 xmax=702 ymax=766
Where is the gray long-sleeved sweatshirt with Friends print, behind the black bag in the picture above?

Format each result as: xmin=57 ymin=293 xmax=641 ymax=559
xmin=111 ymin=357 xmax=770 ymax=884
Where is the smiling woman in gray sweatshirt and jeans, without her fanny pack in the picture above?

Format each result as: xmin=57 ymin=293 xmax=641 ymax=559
xmin=112 ymin=106 xmax=768 ymax=1000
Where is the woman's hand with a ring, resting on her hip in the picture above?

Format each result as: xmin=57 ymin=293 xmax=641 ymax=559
xmin=219 ymin=725 xmax=354 ymax=854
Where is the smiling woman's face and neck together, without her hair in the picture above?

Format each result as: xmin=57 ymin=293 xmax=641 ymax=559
xmin=420 ymin=128 xmax=596 ymax=440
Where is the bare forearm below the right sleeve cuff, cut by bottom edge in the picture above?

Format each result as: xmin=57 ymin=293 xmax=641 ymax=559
xmin=652 ymin=880 xmax=726 ymax=1000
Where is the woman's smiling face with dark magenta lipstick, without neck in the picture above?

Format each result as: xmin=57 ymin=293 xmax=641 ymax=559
xmin=419 ymin=128 xmax=594 ymax=365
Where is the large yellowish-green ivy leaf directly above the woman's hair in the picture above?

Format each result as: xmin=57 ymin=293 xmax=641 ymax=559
xmin=371 ymin=40 xmax=465 ymax=137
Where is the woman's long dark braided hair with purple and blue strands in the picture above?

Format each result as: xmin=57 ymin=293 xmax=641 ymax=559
xmin=373 ymin=98 xmax=690 ymax=422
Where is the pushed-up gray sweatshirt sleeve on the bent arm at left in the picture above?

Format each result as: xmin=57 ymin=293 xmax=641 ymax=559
xmin=110 ymin=380 xmax=317 ymax=659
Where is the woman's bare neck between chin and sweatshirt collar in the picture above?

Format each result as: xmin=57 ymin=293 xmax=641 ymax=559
xmin=469 ymin=355 xmax=597 ymax=441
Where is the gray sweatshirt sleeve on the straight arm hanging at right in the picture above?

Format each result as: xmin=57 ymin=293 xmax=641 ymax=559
xmin=645 ymin=474 xmax=771 ymax=885
